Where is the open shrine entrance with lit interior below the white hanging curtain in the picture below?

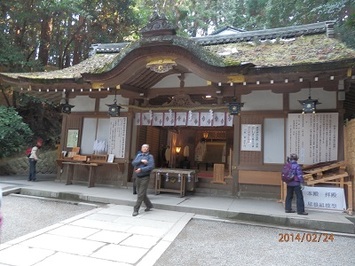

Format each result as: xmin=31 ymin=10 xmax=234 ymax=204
xmin=137 ymin=123 xmax=234 ymax=195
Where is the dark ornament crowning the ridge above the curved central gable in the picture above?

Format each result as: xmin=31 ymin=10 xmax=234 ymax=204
xmin=141 ymin=11 xmax=176 ymax=38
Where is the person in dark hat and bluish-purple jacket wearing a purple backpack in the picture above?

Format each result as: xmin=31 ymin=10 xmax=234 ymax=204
xmin=285 ymin=153 xmax=308 ymax=215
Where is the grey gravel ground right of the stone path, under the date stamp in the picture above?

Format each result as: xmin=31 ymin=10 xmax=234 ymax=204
xmin=154 ymin=219 xmax=355 ymax=266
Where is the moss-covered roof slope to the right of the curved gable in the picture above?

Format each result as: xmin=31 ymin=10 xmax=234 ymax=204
xmin=205 ymin=34 xmax=355 ymax=67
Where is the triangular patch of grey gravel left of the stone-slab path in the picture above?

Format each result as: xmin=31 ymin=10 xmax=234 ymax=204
xmin=1 ymin=195 xmax=95 ymax=243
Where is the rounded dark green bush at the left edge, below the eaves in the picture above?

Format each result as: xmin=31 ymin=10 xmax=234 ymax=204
xmin=0 ymin=106 xmax=33 ymax=158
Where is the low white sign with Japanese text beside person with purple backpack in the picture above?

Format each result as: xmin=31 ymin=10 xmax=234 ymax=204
xmin=303 ymin=186 xmax=346 ymax=211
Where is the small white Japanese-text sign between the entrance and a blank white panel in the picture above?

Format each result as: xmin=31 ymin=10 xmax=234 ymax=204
xmin=241 ymin=124 xmax=261 ymax=151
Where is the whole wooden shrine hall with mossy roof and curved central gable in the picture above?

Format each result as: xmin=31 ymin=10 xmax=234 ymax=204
xmin=0 ymin=14 xmax=355 ymax=208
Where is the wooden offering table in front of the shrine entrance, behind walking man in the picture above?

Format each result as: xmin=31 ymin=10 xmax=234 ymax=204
xmin=152 ymin=168 xmax=196 ymax=197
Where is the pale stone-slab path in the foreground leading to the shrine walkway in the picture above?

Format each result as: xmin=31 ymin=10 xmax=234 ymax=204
xmin=0 ymin=205 xmax=193 ymax=266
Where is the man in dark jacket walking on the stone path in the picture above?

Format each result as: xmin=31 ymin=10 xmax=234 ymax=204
xmin=132 ymin=144 xmax=155 ymax=216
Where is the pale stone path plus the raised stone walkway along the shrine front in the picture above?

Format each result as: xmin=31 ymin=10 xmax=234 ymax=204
xmin=0 ymin=176 xmax=355 ymax=266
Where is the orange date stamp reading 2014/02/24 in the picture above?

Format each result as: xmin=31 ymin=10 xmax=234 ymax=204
xmin=278 ymin=232 xmax=334 ymax=243
